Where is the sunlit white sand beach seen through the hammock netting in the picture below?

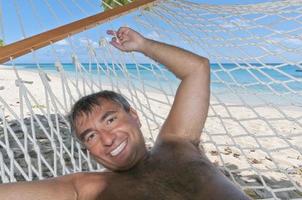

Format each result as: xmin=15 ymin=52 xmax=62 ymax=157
xmin=0 ymin=66 xmax=302 ymax=197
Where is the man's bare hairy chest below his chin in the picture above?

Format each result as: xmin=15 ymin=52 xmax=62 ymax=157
xmin=99 ymin=142 xmax=211 ymax=200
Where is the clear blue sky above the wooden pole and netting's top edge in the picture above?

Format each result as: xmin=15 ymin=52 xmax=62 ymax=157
xmin=0 ymin=0 xmax=274 ymax=43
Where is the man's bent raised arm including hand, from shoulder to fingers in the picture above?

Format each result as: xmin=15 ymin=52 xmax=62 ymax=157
xmin=108 ymin=27 xmax=210 ymax=145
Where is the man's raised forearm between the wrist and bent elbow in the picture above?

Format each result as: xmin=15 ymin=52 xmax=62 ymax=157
xmin=140 ymin=39 xmax=209 ymax=79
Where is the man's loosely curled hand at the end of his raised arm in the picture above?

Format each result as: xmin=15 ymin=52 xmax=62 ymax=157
xmin=107 ymin=27 xmax=145 ymax=52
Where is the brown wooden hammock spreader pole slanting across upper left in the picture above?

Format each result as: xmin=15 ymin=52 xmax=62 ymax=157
xmin=0 ymin=0 xmax=156 ymax=63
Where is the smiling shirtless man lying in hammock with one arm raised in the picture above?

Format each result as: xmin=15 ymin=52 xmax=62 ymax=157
xmin=0 ymin=27 xmax=248 ymax=200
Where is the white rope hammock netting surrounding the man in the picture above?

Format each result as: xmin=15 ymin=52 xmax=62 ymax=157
xmin=0 ymin=0 xmax=302 ymax=199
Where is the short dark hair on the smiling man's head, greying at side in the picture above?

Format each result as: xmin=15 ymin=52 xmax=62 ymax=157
xmin=68 ymin=90 xmax=130 ymax=138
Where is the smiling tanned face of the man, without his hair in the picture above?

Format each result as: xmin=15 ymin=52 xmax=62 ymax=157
xmin=75 ymin=99 xmax=146 ymax=171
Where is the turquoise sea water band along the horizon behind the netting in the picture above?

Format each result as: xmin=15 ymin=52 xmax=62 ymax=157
xmin=10 ymin=63 xmax=302 ymax=94
